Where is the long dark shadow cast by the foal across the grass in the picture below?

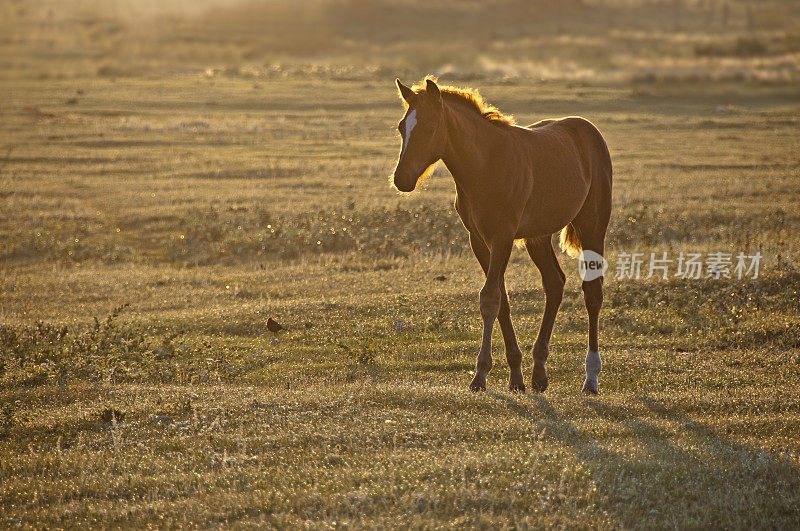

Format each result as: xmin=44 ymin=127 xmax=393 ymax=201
xmin=487 ymin=392 xmax=800 ymax=528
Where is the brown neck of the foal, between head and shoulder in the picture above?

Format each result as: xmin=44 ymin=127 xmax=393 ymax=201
xmin=442 ymin=102 xmax=505 ymax=194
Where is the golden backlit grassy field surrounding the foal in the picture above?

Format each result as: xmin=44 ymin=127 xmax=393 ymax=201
xmin=0 ymin=0 xmax=800 ymax=529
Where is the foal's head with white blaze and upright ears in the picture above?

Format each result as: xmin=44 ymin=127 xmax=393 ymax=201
xmin=394 ymin=79 xmax=446 ymax=192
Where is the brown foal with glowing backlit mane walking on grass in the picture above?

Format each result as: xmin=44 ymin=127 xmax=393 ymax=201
xmin=394 ymin=78 xmax=611 ymax=393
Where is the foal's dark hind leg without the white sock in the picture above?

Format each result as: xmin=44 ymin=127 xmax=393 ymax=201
xmin=525 ymin=236 xmax=566 ymax=393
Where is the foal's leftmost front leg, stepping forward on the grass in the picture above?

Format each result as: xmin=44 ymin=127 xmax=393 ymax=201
xmin=469 ymin=238 xmax=513 ymax=391
